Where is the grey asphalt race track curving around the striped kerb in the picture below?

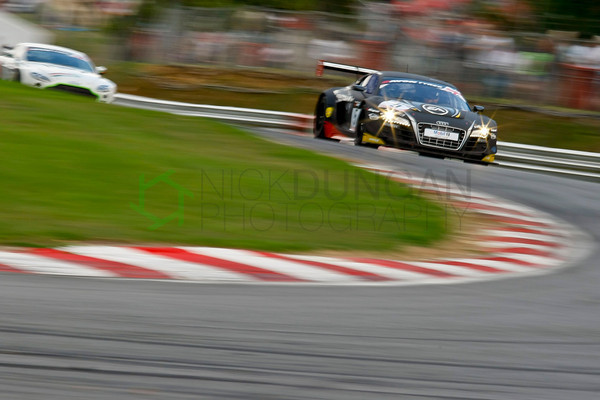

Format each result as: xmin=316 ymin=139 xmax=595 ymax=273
xmin=0 ymin=131 xmax=600 ymax=400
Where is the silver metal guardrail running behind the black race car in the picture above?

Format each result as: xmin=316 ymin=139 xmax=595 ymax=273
xmin=115 ymin=93 xmax=600 ymax=180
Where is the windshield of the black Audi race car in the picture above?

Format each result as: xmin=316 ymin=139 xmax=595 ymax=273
xmin=379 ymin=79 xmax=469 ymax=111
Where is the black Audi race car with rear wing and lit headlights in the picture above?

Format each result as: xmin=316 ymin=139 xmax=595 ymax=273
xmin=314 ymin=61 xmax=498 ymax=163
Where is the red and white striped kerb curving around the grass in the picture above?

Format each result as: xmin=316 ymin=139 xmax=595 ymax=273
xmin=0 ymin=166 xmax=591 ymax=285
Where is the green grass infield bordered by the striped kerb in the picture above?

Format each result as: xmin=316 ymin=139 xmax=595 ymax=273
xmin=0 ymin=82 xmax=453 ymax=251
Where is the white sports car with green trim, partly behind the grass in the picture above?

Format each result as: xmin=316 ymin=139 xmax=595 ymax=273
xmin=0 ymin=43 xmax=117 ymax=103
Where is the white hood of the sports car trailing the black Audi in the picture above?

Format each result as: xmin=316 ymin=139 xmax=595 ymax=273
xmin=29 ymin=63 xmax=115 ymax=91
